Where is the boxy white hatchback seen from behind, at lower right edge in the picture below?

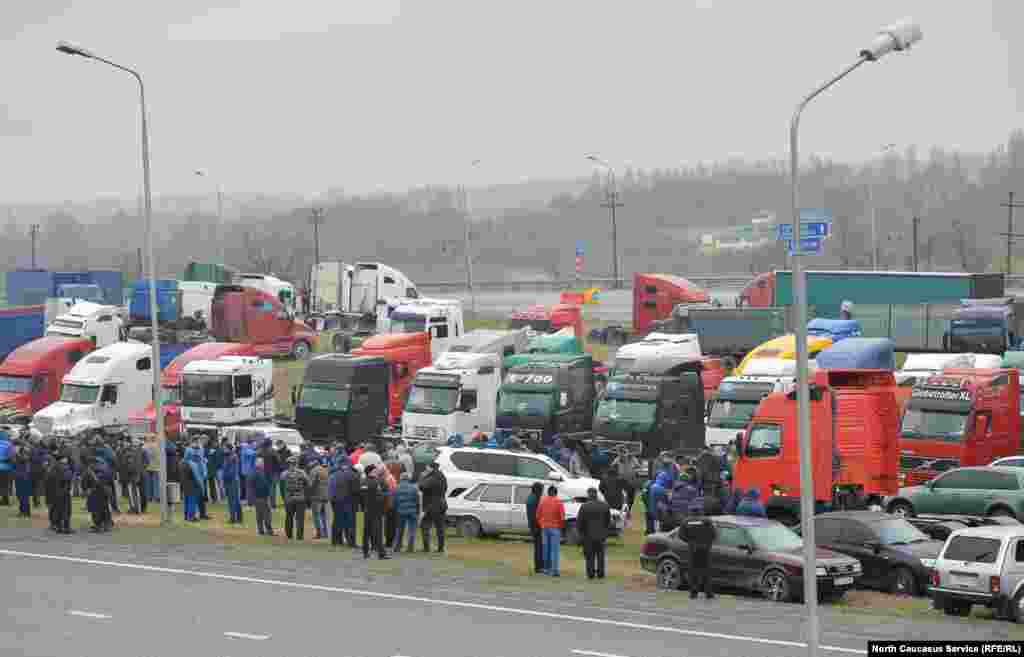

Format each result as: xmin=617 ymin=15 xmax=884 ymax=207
xmin=930 ymin=525 xmax=1024 ymax=623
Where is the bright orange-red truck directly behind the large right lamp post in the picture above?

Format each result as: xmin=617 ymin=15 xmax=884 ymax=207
xmin=733 ymin=369 xmax=899 ymax=520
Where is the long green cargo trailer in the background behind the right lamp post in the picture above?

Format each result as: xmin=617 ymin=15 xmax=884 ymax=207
xmin=774 ymin=271 xmax=1006 ymax=315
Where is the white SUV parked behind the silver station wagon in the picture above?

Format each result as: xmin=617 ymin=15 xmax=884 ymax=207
xmin=435 ymin=447 xmax=601 ymax=501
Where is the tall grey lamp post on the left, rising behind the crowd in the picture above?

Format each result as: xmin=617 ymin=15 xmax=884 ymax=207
xmin=57 ymin=41 xmax=171 ymax=525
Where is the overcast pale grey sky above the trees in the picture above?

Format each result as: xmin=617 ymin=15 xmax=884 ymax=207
xmin=0 ymin=0 xmax=1024 ymax=202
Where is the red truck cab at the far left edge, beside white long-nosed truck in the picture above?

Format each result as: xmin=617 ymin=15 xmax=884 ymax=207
xmin=0 ymin=336 xmax=95 ymax=422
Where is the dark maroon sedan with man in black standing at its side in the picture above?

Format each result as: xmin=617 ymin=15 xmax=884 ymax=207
xmin=640 ymin=516 xmax=861 ymax=602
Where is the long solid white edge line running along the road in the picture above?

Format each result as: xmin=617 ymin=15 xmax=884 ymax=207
xmin=0 ymin=550 xmax=864 ymax=655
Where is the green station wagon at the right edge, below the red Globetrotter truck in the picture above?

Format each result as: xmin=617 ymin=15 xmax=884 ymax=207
xmin=887 ymin=466 xmax=1024 ymax=519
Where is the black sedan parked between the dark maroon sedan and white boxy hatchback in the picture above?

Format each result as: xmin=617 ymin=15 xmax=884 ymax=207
xmin=814 ymin=511 xmax=942 ymax=596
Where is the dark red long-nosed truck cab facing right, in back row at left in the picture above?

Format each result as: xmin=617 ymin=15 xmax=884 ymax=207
xmin=210 ymin=286 xmax=316 ymax=359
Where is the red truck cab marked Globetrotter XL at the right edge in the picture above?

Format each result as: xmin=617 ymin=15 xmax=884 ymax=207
xmin=899 ymin=368 xmax=1020 ymax=485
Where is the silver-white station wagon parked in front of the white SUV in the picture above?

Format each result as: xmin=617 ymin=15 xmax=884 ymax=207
xmin=447 ymin=474 xmax=623 ymax=545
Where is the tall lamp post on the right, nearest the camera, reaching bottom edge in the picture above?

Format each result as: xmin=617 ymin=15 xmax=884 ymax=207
xmin=790 ymin=19 xmax=923 ymax=657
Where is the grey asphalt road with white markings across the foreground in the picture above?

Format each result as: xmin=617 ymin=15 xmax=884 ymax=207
xmin=0 ymin=529 xmax=1011 ymax=657
